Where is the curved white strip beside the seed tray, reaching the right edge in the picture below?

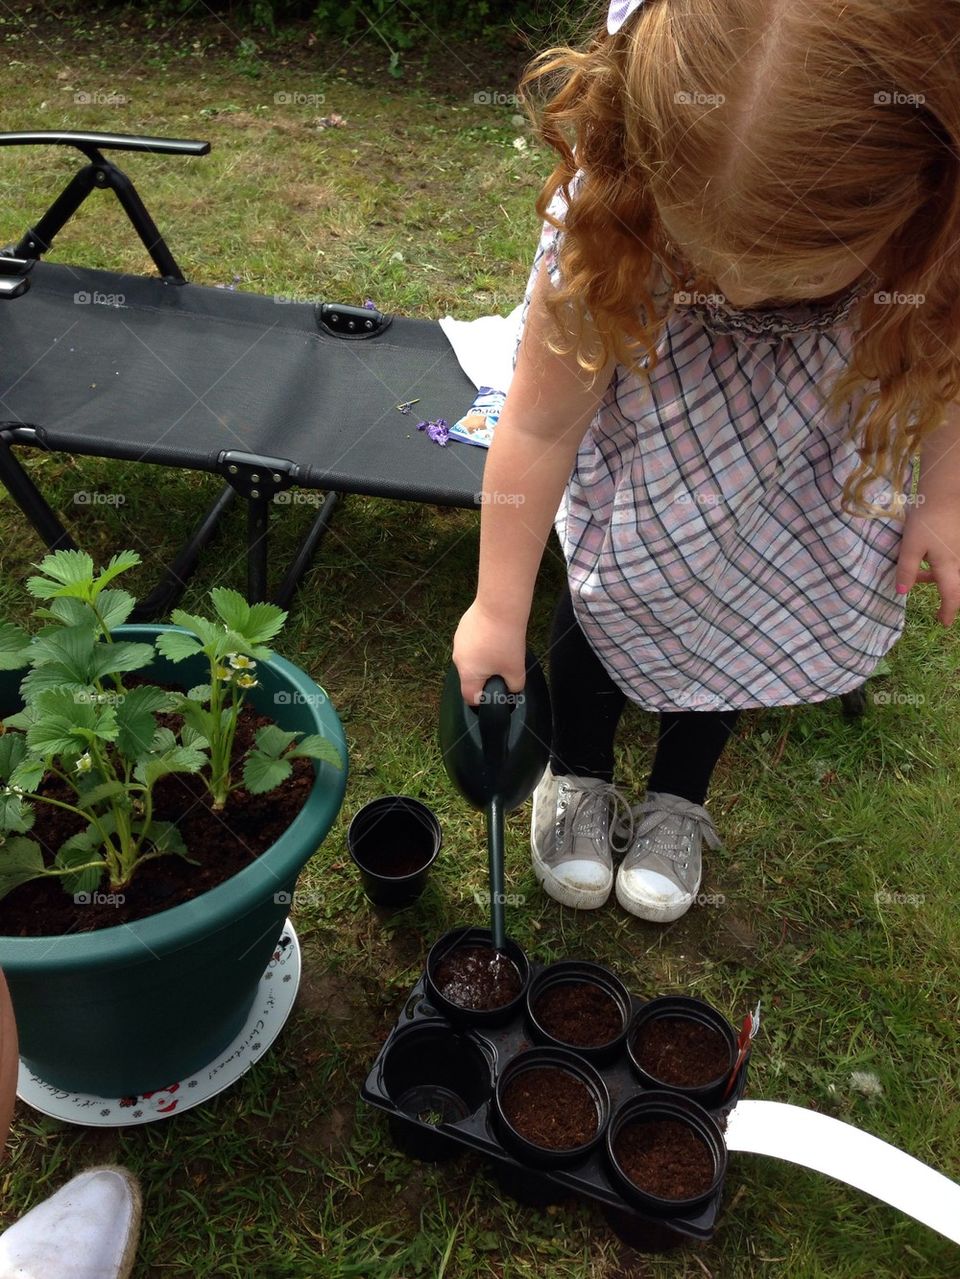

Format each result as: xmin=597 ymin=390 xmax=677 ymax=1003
xmin=726 ymin=1101 xmax=960 ymax=1243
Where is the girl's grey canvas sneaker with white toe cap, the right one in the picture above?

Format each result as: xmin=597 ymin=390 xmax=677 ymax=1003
xmin=616 ymin=790 xmax=722 ymax=923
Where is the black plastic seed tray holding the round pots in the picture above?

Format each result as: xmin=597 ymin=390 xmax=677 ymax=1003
xmin=360 ymin=961 xmax=749 ymax=1246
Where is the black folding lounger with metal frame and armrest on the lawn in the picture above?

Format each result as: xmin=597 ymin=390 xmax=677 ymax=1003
xmin=0 ymin=132 xmax=486 ymax=620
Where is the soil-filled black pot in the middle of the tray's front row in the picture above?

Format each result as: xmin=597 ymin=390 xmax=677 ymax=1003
xmin=493 ymin=1048 xmax=610 ymax=1168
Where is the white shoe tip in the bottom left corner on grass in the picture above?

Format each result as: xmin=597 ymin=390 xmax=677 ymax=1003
xmin=0 ymin=1168 xmax=141 ymax=1279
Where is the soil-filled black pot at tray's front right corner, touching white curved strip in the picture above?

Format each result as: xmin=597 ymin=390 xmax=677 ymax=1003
xmin=606 ymin=1092 xmax=727 ymax=1216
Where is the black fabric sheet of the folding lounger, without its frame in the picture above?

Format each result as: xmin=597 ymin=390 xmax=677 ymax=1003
xmin=0 ymin=262 xmax=486 ymax=506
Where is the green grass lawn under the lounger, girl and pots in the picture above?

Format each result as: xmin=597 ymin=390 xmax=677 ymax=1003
xmin=0 ymin=9 xmax=960 ymax=1279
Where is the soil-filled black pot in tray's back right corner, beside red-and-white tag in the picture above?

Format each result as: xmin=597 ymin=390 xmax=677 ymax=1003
xmin=626 ymin=995 xmax=738 ymax=1109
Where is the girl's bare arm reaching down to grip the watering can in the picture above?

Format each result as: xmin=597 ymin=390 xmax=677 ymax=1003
xmin=454 ymin=270 xmax=616 ymax=703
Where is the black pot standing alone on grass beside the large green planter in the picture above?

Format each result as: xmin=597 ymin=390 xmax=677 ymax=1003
xmin=346 ymin=796 xmax=442 ymax=907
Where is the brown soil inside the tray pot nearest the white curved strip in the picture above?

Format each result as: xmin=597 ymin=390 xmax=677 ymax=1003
xmin=614 ymin=1119 xmax=713 ymax=1200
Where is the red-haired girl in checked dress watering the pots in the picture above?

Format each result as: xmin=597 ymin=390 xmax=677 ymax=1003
xmin=454 ymin=0 xmax=960 ymax=921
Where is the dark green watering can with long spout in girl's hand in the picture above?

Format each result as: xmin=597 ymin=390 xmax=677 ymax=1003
xmin=440 ymin=651 xmax=552 ymax=950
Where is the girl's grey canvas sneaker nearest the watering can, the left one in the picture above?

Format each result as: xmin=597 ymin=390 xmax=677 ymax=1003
xmin=530 ymin=765 xmax=633 ymax=911
